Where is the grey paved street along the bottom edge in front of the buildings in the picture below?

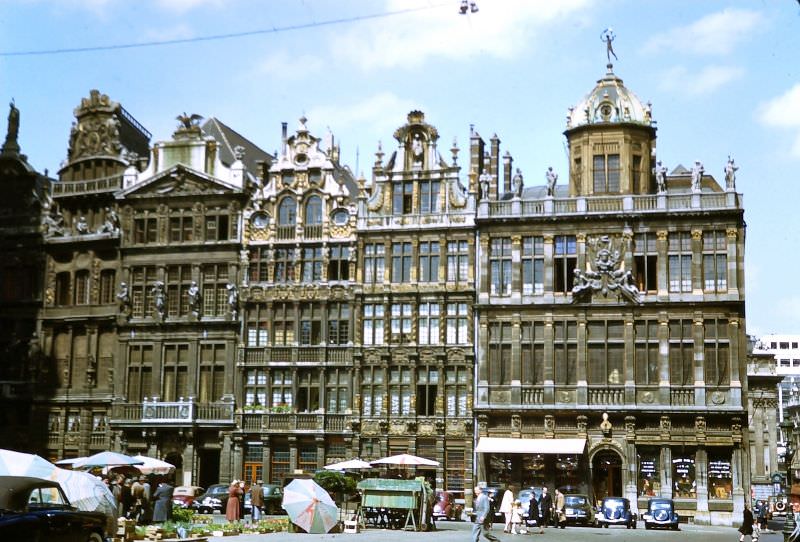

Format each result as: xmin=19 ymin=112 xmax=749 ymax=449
xmin=209 ymin=522 xmax=783 ymax=542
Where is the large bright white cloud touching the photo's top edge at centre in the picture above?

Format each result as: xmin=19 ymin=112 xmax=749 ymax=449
xmin=332 ymin=0 xmax=591 ymax=70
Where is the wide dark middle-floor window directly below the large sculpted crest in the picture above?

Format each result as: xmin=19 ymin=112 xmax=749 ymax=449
xmin=586 ymin=320 xmax=625 ymax=386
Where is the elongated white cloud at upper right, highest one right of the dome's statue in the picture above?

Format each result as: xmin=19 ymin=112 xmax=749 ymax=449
xmin=644 ymin=8 xmax=765 ymax=55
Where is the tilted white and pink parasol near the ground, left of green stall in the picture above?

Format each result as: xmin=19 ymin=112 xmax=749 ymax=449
xmin=283 ymin=479 xmax=339 ymax=534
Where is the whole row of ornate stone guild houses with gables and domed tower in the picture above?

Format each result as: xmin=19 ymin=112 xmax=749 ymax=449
xmin=0 ymin=53 xmax=752 ymax=524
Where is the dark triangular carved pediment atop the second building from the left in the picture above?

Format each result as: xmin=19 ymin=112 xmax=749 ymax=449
xmin=120 ymin=165 xmax=239 ymax=198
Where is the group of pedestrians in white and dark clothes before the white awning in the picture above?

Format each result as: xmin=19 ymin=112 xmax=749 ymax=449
xmin=472 ymin=486 xmax=566 ymax=542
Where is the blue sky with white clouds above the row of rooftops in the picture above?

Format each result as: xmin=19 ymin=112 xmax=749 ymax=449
xmin=0 ymin=0 xmax=800 ymax=335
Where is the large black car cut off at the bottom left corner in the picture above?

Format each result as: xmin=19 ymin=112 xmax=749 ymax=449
xmin=0 ymin=476 xmax=111 ymax=542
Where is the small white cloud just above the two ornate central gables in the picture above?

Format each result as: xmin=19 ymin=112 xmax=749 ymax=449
xmin=308 ymin=92 xmax=423 ymax=137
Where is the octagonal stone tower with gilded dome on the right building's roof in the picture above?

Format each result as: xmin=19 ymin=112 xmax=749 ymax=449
xmin=564 ymin=62 xmax=656 ymax=196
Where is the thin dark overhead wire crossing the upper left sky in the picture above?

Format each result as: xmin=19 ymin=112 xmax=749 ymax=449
xmin=0 ymin=2 xmax=450 ymax=57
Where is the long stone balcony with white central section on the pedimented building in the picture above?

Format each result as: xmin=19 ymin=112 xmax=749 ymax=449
xmin=111 ymin=399 xmax=234 ymax=426
